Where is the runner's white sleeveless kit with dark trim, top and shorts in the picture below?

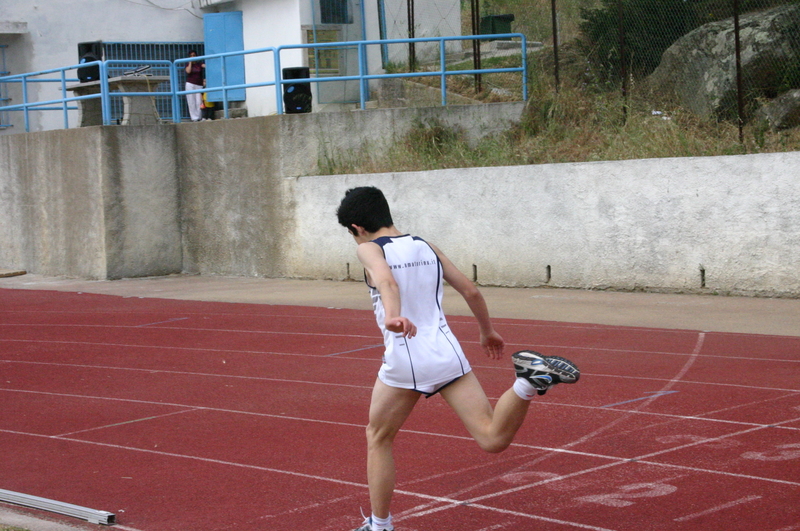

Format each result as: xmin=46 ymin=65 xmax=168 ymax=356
xmin=367 ymin=235 xmax=470 ymax=395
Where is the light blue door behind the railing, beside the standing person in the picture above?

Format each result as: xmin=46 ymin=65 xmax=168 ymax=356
xmin=203 ymin=11 xmax=245 ymax=102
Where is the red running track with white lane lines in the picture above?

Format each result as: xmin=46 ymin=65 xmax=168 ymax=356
xmin=0 ymin=289 xmax=800 ymax=531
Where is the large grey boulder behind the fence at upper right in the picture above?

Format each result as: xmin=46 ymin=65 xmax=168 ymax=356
xmin=648 ymin=4 xmax=800 ymax=119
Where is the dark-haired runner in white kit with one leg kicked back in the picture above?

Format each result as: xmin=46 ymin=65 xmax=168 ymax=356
xmin=337 ymin=187 xmax=580 ymax=531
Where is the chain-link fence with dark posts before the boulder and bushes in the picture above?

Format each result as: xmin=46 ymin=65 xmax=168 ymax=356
xmin=384 ymin=0 xmax=800 ymax=137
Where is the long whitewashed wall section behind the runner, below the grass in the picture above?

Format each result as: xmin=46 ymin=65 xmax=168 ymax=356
xmin=287 ymin=152 xmax=800 ymax=294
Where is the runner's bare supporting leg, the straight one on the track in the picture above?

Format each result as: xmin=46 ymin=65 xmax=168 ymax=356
xmin=367 ymin=380 xmax=420 ymax=518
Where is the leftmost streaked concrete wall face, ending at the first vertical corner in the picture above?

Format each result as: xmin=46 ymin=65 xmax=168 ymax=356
xmin=0 ymin=128 xmax=106 ymax=278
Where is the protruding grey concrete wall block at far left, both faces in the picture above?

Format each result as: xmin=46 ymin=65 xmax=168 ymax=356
xmin=0 ymin=127 xmax=182 ymax=278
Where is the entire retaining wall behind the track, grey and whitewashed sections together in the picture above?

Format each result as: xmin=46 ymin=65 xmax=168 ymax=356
xmin=0 ymin=105 xmax=800 ymax=296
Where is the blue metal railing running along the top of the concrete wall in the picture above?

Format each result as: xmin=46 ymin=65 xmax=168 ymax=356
xmin=0 ymin=33 xmax=528 ymax=131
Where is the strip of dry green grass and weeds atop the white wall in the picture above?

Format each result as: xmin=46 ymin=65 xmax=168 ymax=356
xmin=325 ymin=83 xmax=800 ymax=174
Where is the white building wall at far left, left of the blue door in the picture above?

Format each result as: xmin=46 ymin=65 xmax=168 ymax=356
xmin=0 ymin=0 xmax=203 ymax=134
